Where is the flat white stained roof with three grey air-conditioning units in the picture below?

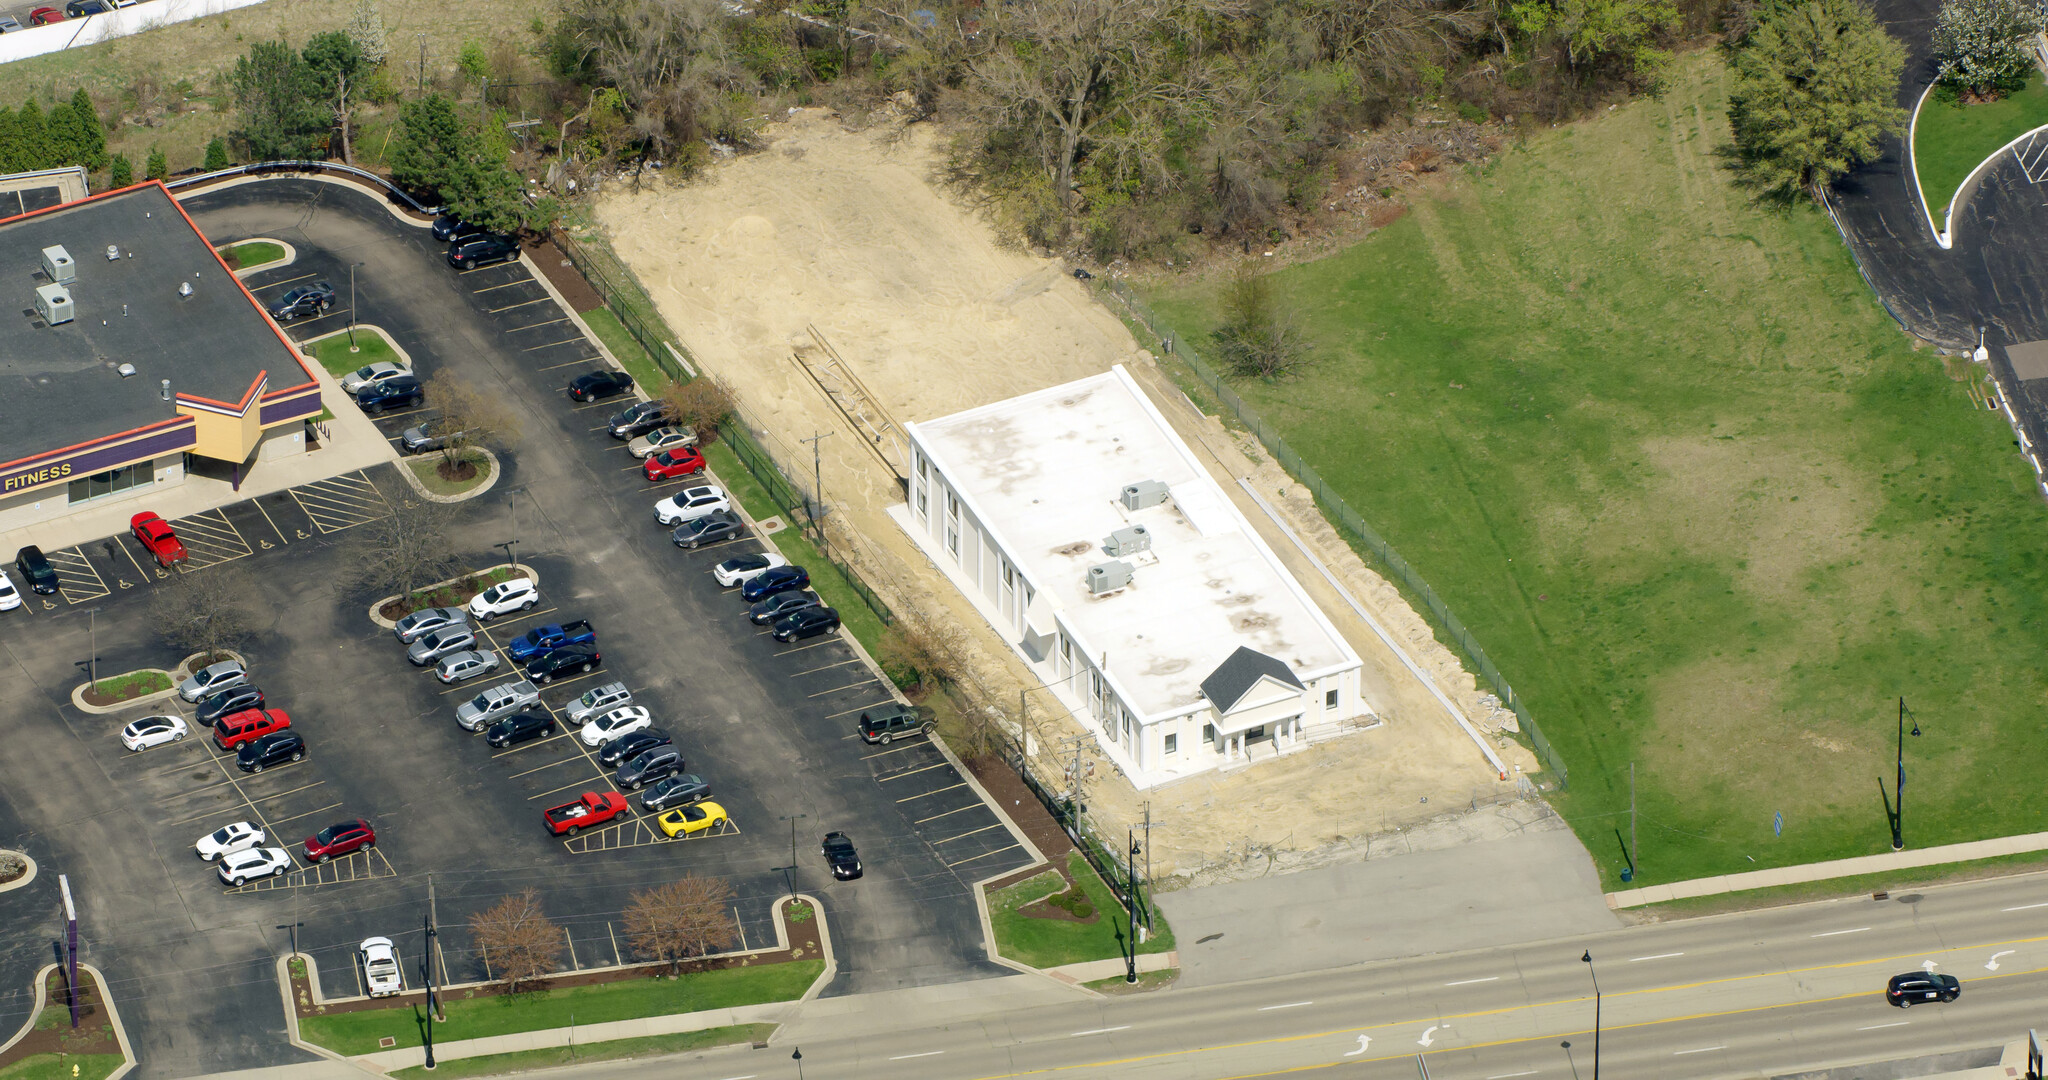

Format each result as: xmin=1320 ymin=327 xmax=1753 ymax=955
xmin=909 ymin=365 xmax=1358 ymax=717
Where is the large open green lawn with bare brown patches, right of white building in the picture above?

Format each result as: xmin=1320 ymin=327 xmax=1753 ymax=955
xmin=1153 ymin=51 xmax=2048 ymax=885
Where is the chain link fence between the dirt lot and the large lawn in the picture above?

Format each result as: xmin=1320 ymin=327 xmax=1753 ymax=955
xmin=1096 ymin=279 xmax=1569 ymax=789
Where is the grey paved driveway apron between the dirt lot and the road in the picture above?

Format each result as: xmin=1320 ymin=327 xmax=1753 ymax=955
xmin=1157 ymin=818 xmax=1620 ymax=986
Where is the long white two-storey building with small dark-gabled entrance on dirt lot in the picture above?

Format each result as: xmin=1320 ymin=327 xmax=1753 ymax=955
xmin=893 ymin=367 xmax=1372 ymax=787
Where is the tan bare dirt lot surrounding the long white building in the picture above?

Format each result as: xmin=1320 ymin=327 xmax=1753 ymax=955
xmin=598 ymin=111 xmax=1534 ymax=881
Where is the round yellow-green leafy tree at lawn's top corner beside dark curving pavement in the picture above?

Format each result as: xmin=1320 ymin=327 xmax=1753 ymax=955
xmin=1729 ymin=0 xmax=1905 ymax=197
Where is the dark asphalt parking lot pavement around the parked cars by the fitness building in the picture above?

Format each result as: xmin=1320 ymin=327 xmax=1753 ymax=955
xmin=0 ymin=180 xmax=1028 ymax=1076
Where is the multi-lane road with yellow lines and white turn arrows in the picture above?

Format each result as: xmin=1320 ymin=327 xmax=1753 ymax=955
xmin=557 ymin=875 xmax=2048 ymax=1080
